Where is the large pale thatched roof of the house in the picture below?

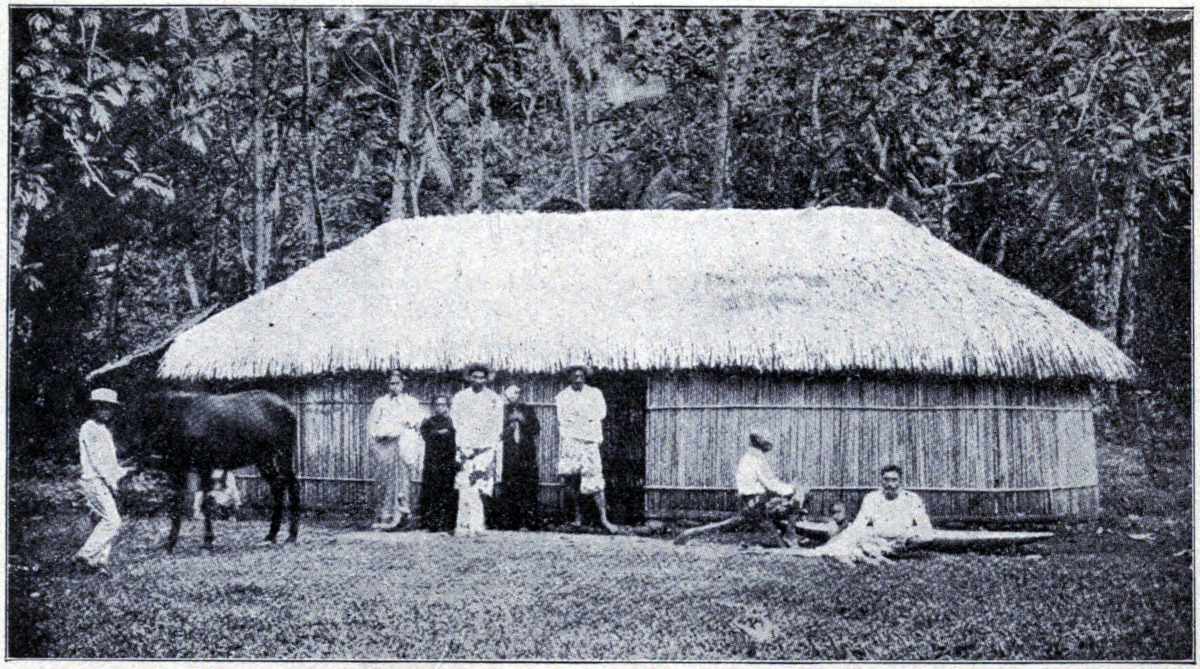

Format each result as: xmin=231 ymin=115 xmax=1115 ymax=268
xmin=160 ymin=207 xmax=1134 ymax=380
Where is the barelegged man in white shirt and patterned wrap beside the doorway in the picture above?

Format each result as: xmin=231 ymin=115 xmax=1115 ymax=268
xmin=554 ymin=364 xmax=617 ymax=534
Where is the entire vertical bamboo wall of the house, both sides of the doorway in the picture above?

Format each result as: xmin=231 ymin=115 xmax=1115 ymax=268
xmin=234 ymin=374 xmax=1098 ymax=519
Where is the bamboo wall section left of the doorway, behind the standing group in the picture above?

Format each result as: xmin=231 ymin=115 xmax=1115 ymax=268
xmin=239 ymin=373 xmax=560 ymax=511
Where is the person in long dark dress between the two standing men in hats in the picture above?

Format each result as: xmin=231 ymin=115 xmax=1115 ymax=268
xmin=497 ymin=385 xmax=541 ymax=530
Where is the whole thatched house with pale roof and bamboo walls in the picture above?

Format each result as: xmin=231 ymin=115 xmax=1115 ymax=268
xmin=160 ymin=209 xmax=1134 ymax=518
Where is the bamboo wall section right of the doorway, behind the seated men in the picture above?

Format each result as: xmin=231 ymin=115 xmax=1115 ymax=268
xmin=646 ymin=374 xmax=1097 ymax=518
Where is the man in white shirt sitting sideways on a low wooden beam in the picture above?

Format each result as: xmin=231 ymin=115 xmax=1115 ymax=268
xmin=674 ymin=428 xmax=808 ymax=548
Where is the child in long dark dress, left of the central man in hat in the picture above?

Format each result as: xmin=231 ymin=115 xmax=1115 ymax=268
xmin=420 ymin=394 xmax=458 ymax=532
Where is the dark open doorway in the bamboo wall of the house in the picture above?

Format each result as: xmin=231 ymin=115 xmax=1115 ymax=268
xmin=583 ymin=372 xmax=647 ymax=525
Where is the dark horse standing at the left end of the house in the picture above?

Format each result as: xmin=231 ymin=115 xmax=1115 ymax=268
xmin=133 ymin=391 xmax=300 ymax=553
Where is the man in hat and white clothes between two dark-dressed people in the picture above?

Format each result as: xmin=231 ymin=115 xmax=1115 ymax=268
xmin=450 ymin=364 xmax=504 ymax=536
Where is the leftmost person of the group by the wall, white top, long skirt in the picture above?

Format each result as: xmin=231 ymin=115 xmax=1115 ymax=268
xmin=367 ymin=370 xmax=425 ymax=530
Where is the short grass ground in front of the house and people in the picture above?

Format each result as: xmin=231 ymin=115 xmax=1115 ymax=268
xmin=8 ymin=508 xmax=1192 ymax=661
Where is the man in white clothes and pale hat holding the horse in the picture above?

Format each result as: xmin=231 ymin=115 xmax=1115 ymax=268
xmin=74 ymin=388 xmax=131 ymax=572
